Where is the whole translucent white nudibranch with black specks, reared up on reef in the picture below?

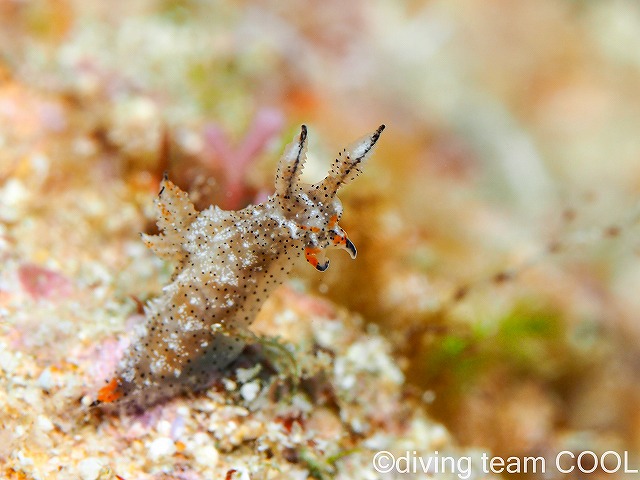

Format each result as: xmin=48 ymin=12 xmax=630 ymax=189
xmin=93 ymin=125 xmax=384 ymax=408
